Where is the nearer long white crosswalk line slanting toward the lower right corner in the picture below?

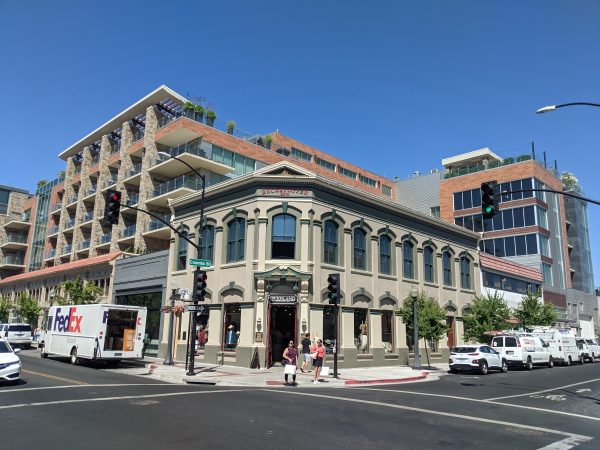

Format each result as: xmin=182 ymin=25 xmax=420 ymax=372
xmin=261 ymin=389 xmax=593 ymax=442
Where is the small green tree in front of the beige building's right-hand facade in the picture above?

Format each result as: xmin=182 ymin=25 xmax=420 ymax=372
xmin=398 ymin=291 xmax=448 ymax=365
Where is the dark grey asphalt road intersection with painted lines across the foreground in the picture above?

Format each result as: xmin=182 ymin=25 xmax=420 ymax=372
xmin=0 ymin=351 xmax=600 ymax=449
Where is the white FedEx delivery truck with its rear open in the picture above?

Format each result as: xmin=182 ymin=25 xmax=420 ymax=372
xmin=39 ymin=304 xmax=147 ymax=364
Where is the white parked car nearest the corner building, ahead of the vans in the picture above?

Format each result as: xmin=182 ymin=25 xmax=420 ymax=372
xmin=448 ymin=344 xmax=508 ymax=375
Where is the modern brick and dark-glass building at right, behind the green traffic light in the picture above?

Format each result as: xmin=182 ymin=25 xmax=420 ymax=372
xmin=398 ymin=148 xmax=598 ymax=335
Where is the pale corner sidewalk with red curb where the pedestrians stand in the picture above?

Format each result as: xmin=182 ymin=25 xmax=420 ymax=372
xmin=112 ymin=358 xmax=448 ymax=388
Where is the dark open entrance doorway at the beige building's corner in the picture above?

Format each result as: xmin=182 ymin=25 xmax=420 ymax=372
xmin=267 ymin=305 xmax=298 ymax=367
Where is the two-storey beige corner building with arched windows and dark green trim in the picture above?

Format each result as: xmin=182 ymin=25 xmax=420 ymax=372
xmin=168 ymin=161 xmax=480 ymax=367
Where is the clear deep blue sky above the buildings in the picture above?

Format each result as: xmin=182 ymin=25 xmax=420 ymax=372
xmin=0 ymin=0 xmax=600 ymax=286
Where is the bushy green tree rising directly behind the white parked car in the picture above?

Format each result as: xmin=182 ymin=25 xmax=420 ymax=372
xmin=463 ymin=291 xmax=511 ymax=344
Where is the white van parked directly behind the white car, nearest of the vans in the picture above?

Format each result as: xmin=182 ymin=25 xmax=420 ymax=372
xmin=491 ymin=333 xmax=554 ymax=370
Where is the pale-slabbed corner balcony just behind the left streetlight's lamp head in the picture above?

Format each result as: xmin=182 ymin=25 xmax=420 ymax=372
xmin=148 ymin=140 xmax=234 ymax=178
